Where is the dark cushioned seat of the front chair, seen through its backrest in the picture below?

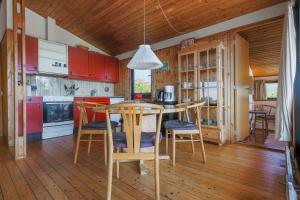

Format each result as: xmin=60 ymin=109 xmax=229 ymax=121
xmin=113 ymin=132 xmax=162 ymax=148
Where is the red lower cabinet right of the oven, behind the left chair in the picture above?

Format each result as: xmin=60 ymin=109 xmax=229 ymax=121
xmin=73 ymin=97 xmax=109 ymax=128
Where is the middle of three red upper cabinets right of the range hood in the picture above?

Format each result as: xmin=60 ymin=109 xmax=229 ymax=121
xmin=89 ymin=51 xmax=106 ymax=81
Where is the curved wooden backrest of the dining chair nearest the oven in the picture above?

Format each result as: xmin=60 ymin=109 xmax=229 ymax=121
xmin=76 ymin=101 xmax=107 ymax=128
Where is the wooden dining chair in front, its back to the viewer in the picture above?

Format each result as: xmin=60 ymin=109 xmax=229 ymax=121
xmin=106 ymin=103 xmax=163 ymax=200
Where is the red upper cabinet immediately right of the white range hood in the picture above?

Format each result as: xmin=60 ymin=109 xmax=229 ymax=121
xmin=68 ymin=47 xmax=89 ymax=78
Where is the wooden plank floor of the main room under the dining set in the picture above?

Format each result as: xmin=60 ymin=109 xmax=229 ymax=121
xmin=0 ymin=136 xmax=285 ymax=200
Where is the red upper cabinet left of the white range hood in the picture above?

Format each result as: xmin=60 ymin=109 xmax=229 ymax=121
xmin=18 ymin=35 xmax=38 ymax=74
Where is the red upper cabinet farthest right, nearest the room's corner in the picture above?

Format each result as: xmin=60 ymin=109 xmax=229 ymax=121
xmin=105 ymin=57 xmax=119 ymax=83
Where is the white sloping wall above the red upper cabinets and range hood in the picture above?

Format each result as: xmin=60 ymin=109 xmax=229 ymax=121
xmin=4 ymin=0 xmax=108 ymax=55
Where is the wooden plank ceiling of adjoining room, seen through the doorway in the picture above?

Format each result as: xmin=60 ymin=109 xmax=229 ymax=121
xmin=240 ymin=18 xmax=283 ymax=77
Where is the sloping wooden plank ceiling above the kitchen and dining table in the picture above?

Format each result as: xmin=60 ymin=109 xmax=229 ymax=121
xmin=26 ymin=0 xmax=285 ymax=55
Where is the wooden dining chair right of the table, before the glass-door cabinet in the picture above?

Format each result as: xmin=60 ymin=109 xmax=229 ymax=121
xmin=164 ymin=102 xmax=206 ymax=166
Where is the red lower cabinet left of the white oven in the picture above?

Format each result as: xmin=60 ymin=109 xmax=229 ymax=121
xmin=18 ymin=97 xmax=43 ymax=141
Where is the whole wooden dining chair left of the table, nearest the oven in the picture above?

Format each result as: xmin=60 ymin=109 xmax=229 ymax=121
xmin=74 ymin=102 xmax=118 ymax=165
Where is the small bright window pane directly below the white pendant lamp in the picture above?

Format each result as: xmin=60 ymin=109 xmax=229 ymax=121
xmin=133 ymin=70 xmax=151 ymax=94
